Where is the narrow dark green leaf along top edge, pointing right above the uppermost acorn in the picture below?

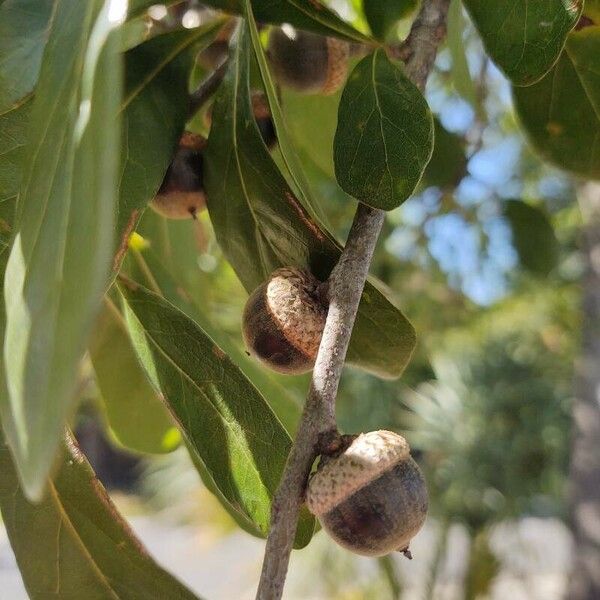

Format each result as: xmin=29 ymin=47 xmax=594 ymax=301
xmin=204 ymin=0 xmax=371 ymax=42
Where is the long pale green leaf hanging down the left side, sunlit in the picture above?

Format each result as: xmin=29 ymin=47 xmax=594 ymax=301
xmin=0 ymin=0 xmax=122 ymax=500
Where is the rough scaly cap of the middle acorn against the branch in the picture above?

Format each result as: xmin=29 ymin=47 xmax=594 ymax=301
xmin=265 ymin=267 xmax=327 ymax=357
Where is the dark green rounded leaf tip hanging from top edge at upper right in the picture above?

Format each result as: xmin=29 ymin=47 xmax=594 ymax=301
xmin=463 ymin=0 xmax=583 ymax=85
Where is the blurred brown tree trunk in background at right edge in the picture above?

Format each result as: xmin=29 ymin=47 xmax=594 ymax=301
xmin=567 ymin=183 xmax=600 ymax=600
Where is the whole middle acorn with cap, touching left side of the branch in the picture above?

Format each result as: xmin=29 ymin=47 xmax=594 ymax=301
xmin=242 ymin=267 xmax=327 ymax=375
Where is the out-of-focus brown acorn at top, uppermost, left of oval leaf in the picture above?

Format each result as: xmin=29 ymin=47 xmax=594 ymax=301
xmin=268 ymin=25 xmax=350 ymax=94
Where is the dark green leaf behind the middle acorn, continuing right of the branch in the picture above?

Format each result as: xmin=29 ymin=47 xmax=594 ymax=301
xmin=204 ymin=30 xmax=415 ymax=377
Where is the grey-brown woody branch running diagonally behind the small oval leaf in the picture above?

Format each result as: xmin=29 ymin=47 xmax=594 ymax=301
xmin=256 ymin=0 xmax=449 ymax=600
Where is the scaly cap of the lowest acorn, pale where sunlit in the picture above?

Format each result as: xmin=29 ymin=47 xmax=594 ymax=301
xmin=306 ymin=430 xmax=410 ymax=517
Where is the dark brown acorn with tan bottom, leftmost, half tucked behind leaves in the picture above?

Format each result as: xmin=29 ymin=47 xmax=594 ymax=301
xmin=150 ymin=131 xmax=206 ymax=219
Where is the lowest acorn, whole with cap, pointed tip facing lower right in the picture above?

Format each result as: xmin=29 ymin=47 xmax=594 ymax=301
xmin=306 ymin=431 xmax=428 ymax=558
